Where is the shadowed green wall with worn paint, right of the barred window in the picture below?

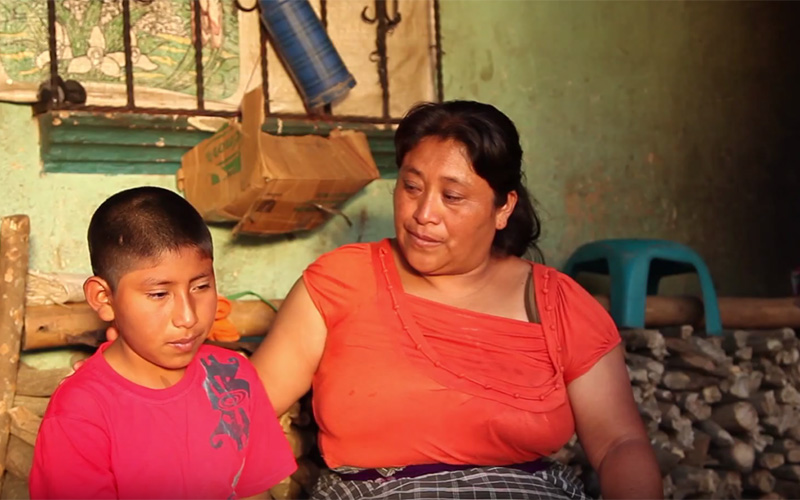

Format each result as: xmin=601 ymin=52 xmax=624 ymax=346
xmin=442 ymin=0 xmax=800 ymax=295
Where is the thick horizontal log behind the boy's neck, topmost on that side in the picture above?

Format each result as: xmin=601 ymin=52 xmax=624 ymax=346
xmin=22 ymin=299 xmax=283 ymax=350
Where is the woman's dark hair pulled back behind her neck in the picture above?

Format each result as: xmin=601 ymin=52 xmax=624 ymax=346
xmin=394 ymin=101 xmax=541 ymax=258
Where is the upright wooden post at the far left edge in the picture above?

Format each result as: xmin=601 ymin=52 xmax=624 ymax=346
xmin=0 ymin=215 xmax=30 ymax=489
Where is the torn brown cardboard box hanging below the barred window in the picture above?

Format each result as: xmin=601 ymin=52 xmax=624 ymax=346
xmin=178 ymin=87 xmax=379 ymax=234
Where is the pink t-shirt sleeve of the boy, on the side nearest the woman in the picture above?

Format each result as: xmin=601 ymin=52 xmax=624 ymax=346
xmin=236 ymin=362 xmax=297 ymax=498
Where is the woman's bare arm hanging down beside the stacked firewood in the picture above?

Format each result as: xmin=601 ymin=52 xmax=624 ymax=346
xmin=567 ymin=346 xmax=664 ymax=499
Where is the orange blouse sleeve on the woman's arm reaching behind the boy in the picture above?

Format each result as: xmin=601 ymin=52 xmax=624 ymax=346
xmin=303 ymin=244 xmax=374 ymax=328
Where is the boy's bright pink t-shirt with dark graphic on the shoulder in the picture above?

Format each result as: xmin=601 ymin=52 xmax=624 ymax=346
xmin=30 ymin=344 xmax=296 ymax=499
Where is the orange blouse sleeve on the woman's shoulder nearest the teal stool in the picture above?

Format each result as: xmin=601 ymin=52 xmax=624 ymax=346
xmin=558 ymin=273 xmax=621 ymax=384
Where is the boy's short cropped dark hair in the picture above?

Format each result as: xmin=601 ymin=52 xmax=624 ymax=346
xmin=88 ymin=186 xmax=214 ymax=290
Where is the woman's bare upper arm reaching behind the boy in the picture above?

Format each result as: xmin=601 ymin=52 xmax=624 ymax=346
xmin=250 ymin=278 xmax=328 ymax=415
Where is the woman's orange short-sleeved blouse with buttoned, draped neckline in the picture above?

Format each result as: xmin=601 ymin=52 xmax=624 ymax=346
xmin=303 ymin=240 xmax=620 ymax=468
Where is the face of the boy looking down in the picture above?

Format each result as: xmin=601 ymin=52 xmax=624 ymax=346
xmin=103 ymin=247 xmax=217 ymax=379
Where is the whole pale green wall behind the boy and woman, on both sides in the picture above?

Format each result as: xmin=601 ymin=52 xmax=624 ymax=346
xmin=0 ymin=0 xmax=800 ymax=297
